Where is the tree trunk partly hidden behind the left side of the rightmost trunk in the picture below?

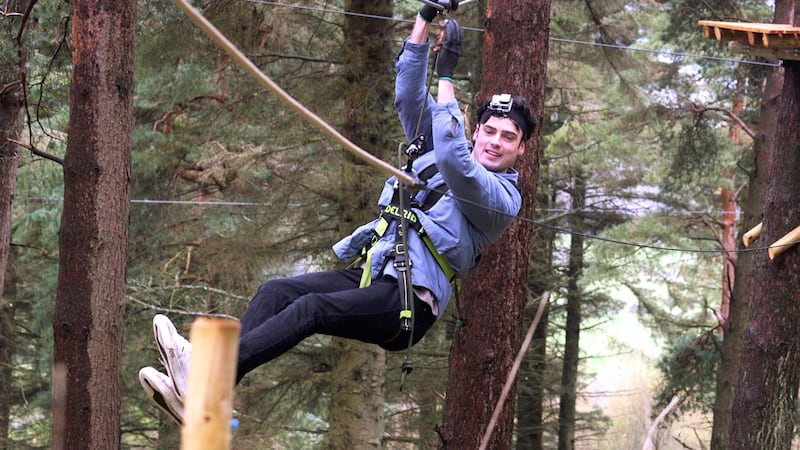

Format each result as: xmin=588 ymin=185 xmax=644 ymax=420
xmin=711 ymin=51 xmax=785 ymax=450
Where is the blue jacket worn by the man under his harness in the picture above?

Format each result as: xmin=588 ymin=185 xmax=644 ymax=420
xmin=333 ymin=41 xmax=522 ymax=312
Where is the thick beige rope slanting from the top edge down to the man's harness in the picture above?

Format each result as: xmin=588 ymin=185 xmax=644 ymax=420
xmin=175 ymin=0 xmax=423 ymax=187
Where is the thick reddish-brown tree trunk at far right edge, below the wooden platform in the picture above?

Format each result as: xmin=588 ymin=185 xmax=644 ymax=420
xmin=731 ymin=13 xmax=800 ymax=449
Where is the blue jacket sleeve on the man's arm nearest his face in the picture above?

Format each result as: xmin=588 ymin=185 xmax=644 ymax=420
xmin=432 ymin=100 xmax=522 ymax=240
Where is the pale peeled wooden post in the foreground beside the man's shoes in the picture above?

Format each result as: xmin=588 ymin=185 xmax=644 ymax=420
xmin=181 ymin=317 xmax=240 ymax=450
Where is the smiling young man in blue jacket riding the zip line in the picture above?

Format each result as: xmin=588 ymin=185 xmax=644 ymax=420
xmin=139 ymin=3 xmax=535 ymax=423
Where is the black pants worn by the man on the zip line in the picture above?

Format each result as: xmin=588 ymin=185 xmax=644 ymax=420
xmin=236 ymin=269 xmax=436 ymax=383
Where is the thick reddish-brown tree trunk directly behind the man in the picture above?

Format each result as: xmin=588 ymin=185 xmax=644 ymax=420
xmin=441 ymin=0 xmax=550 ymax=449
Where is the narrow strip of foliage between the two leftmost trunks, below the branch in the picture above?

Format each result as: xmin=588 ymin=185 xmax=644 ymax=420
xmin=5 ymin=135 xmax=64 ymax=447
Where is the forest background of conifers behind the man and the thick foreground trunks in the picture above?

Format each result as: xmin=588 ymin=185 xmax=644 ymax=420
xmin=2 ymin=0 xmax=788 ymax=449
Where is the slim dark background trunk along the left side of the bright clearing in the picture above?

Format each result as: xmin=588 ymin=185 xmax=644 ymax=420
xmin=558 ymin=169 xmax=586 ymax=450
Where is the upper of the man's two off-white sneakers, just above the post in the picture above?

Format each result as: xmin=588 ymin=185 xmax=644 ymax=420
xmin=153 ymin=314 xmax=192 ymax=401
